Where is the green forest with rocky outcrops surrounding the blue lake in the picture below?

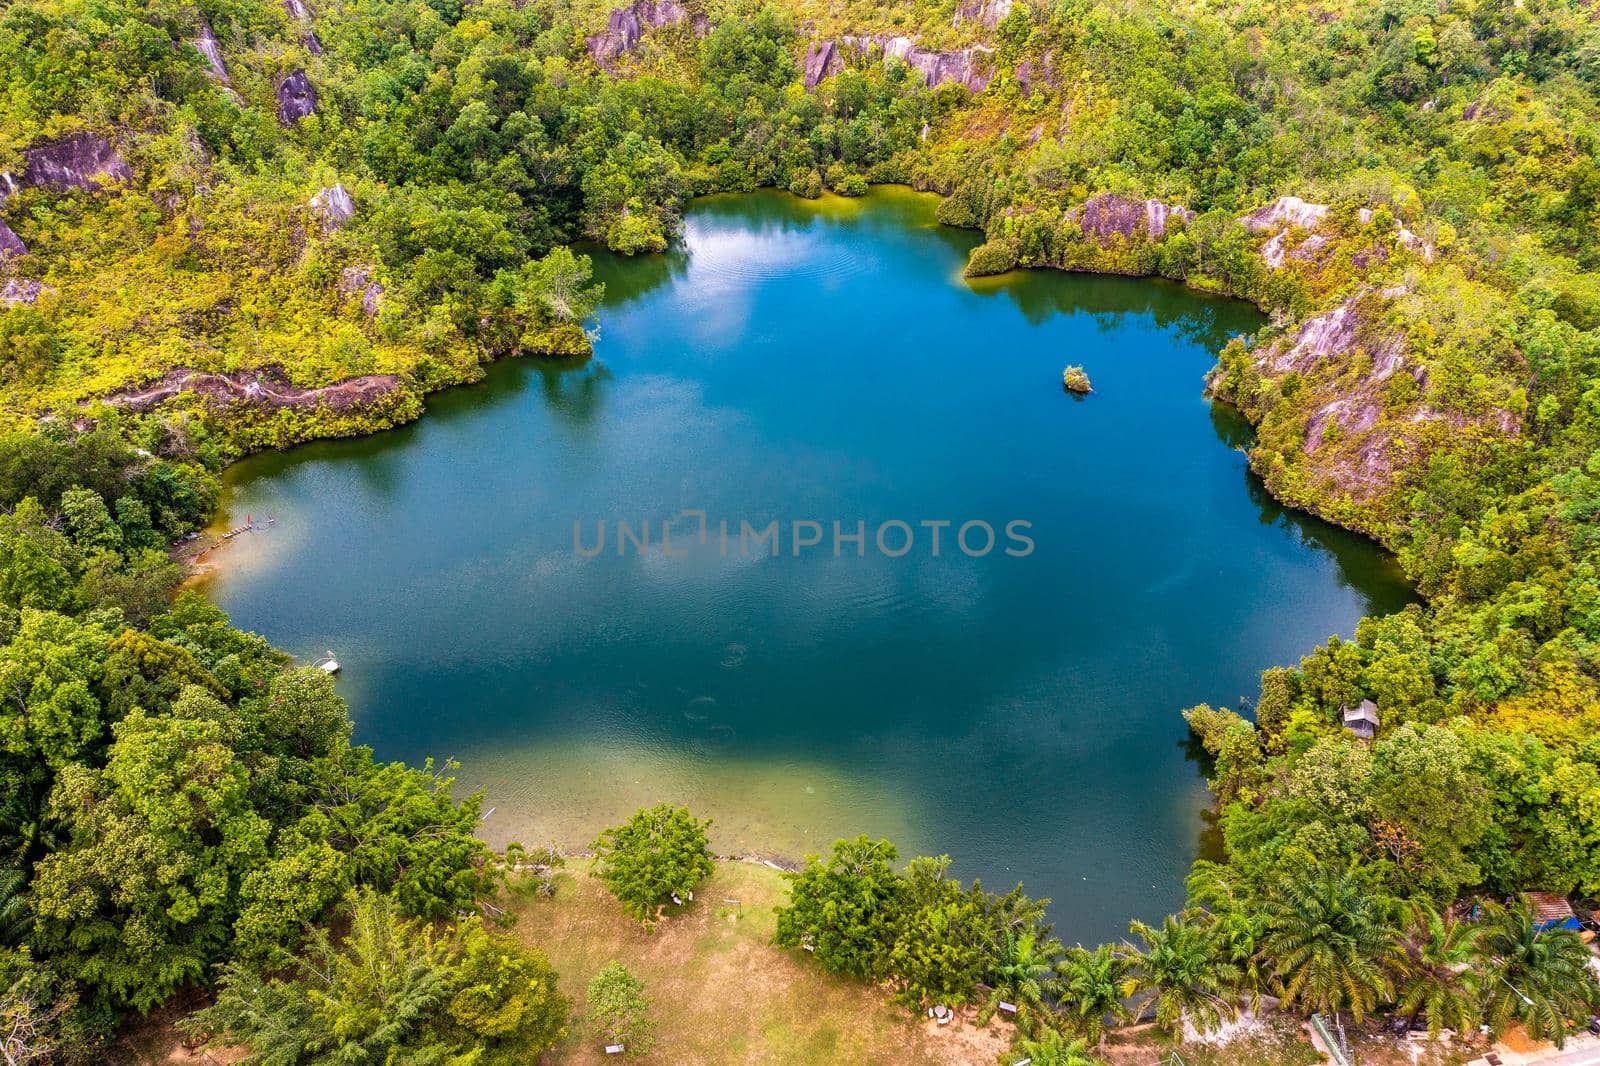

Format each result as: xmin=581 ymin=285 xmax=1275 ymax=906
xmin=0 ymin=0 xmax=1600 ymax=1066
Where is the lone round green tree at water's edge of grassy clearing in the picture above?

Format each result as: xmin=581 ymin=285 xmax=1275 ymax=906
xmin=594 ymin=804 xmax=714 ymax=925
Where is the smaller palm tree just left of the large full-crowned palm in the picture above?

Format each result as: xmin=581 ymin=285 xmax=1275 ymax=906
xmin=1128 ymin=914 xmax=1238 ymax=1034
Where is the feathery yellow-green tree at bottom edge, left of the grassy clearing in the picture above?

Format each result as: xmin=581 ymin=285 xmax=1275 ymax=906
xmin=186 ymin=890 xmax=570 ymax=1066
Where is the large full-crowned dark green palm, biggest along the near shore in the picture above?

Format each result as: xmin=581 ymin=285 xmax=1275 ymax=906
xmin=1261 ymin=866 xmax=1402 ymax=1021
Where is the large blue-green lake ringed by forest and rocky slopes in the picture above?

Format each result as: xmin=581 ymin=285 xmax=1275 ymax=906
xmin=208 ymin=189 xmax=1408 ymax=943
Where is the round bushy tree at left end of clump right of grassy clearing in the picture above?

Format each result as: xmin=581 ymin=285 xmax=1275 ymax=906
xmin=773 ymin=837 xmax=906 ymax=981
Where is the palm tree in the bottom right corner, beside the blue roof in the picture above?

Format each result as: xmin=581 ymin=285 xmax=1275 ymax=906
xmin=1478 ymin=898 xmax=1600 ymax=1047
